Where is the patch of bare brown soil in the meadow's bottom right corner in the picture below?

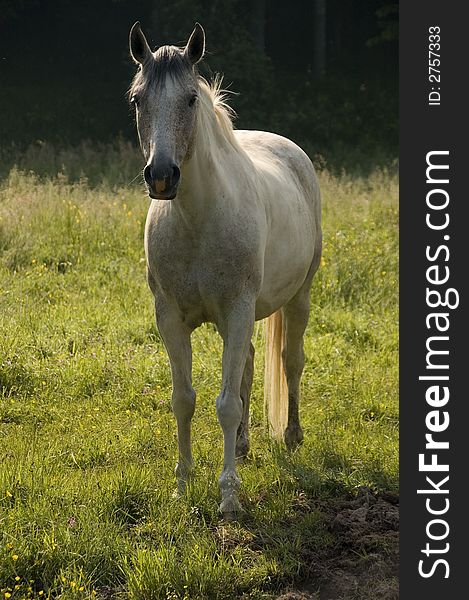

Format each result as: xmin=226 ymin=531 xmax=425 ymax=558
xmin=277 ymin=487 xmax=399 ymax=600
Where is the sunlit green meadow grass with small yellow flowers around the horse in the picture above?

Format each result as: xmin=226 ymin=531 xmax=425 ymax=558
xmin=0 ymin=156 xmax=398 ymax=600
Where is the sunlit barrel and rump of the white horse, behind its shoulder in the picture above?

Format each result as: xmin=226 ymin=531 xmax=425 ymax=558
xmin=236 ymin=130 xmax=322 ymax=318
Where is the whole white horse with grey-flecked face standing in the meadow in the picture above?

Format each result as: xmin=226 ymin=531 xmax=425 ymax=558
xmin=130 ymin=23 xmax=321 ymax=518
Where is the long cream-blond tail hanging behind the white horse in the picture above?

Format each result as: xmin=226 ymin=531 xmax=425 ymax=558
xmin=264 ymin=310 xmax=288 ymax=439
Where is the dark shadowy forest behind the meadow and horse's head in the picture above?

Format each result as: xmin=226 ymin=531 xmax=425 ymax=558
xmin=0 ymin=0 xmax=398 ymax=168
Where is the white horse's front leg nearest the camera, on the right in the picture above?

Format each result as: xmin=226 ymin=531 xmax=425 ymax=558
xmin=217 ymin=302 xmax=254 ymax=519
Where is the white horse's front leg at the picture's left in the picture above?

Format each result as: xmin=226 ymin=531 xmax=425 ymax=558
xmin=156 ymin=307 xmax=195 ymax=494
